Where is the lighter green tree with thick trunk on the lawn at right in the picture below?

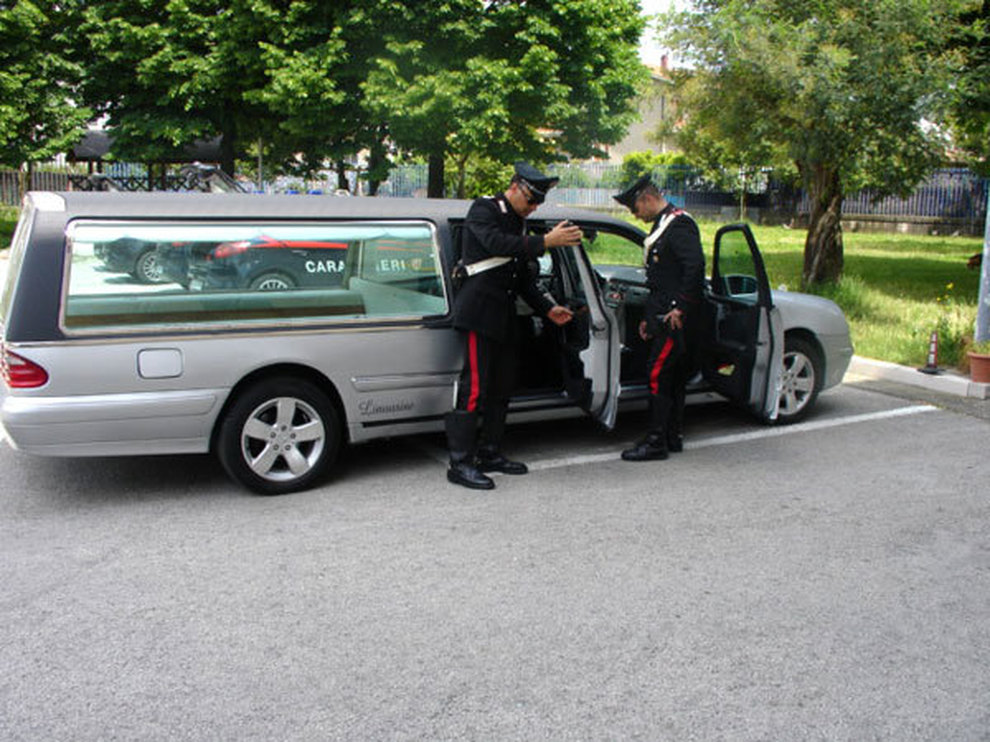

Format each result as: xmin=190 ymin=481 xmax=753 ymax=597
xmin=665 ymin=0 xmax=949 ymax=284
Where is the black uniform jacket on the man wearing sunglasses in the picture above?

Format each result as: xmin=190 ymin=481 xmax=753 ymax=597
xmin=454 ymin=194 xmax=553 ymax=342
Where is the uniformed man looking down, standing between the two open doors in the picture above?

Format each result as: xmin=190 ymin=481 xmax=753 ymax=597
xmin=613 ymin=175 xmax=705 ymax=461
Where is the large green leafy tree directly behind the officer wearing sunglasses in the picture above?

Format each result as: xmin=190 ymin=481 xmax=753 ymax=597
xmin=364 ymin=0 xmax=645 ymax=196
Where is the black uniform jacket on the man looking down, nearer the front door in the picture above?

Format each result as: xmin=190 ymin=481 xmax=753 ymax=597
xmin=644 ymin=204 xmax=705 ymax=335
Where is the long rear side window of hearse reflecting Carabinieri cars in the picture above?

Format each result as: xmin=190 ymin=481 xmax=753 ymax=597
xmin=63 ymin=220 xmax=447 ymax=331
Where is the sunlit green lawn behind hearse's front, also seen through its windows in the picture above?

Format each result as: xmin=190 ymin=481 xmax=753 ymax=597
xmin=592 ymin=221 xmax=983 ymax=368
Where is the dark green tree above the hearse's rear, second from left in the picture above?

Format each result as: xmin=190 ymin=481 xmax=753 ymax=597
xmin=79 ymin=0 xmax=288 ymax=174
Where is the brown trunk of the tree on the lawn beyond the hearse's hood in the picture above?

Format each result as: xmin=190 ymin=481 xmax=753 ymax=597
xmin=801 ymin=166 xmax=842 ymax=286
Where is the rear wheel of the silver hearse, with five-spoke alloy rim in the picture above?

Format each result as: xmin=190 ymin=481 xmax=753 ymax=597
xmin=216 ymin=377 xmax=343 ymax=495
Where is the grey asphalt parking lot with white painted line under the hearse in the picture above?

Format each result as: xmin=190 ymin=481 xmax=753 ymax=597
xmin=0 ymin=251 xmax=990 ymax=742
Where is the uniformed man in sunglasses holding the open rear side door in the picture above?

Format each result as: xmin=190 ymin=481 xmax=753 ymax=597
xmin=446 ymin=162 xmax=581 ymax=489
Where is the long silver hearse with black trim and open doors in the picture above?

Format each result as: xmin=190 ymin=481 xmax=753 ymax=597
xmin=0 ymin=192 xmax=852 ymax=494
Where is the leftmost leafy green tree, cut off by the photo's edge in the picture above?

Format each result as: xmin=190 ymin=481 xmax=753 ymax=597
xmin=0 ymin=0 xmax=91 ymax=190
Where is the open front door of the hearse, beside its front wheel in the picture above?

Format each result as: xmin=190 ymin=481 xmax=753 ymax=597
xmin=700 ymin=224 xmax=784 ymax=420
